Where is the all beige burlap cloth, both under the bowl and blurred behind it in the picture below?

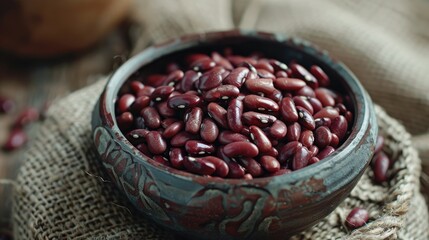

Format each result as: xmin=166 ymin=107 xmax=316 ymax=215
xmin=13 ymin=0 xmax=429 ymax=239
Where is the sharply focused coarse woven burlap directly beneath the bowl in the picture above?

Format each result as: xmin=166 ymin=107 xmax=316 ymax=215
xmin=13 ymin=80 xmax=429 ymax=239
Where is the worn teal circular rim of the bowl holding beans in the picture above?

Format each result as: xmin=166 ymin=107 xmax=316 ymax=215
xmin=100 ymin=29 xmax=373 ymax=186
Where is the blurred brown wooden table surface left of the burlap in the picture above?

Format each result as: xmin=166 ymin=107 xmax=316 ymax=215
xmin=0 ymin=29 xmax=129 ymax=233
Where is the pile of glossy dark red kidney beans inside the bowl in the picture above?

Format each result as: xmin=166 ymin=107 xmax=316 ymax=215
xmin=116 ymin=51 xmax=353 ymax=179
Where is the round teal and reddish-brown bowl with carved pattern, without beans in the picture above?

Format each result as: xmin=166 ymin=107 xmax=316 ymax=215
xmin=92 ymin=30 xmax=378 ymax=239
